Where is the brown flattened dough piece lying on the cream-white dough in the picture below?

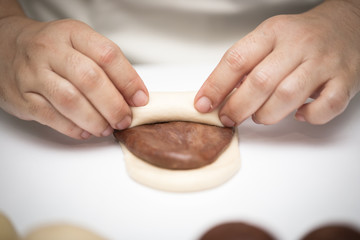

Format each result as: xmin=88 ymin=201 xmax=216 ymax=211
xmin=114 ymin=122 xmax=234 ymax=170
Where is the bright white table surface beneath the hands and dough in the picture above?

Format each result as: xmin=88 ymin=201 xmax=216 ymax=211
xmin=0 ymin=65 xmax=360 ymax=240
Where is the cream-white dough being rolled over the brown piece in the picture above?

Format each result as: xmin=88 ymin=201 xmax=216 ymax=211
xmin=120 ymin=92 xmax=240 ymax=192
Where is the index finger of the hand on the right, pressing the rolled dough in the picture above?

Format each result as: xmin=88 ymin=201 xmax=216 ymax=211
xmin=194 ymin=27 xmax=275 ymax=112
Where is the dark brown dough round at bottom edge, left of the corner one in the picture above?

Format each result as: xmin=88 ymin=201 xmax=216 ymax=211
xmin=200 ymin=222 xmax=275 ymax=240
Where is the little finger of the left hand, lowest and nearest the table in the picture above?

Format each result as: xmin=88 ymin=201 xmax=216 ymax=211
xmin=25 ymin=92 xmax=91 ymax=139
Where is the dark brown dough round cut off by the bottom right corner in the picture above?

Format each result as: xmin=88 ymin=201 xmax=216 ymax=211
xmin=302 ymin=225 xmax=360 ymax=240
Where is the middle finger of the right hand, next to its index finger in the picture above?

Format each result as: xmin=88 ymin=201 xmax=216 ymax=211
xmin=219 ymin=45 xmax=302 ymax=127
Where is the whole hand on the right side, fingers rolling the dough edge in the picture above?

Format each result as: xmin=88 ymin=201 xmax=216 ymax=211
xmin=195 ymin=0 xmax=360 ymax=126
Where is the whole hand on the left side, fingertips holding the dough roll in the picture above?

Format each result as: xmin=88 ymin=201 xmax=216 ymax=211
xmin=0 ymin=17 xmax=148 ymax=139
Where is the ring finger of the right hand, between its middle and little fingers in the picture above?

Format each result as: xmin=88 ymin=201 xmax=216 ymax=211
xmin=253 ymin=61 xmax=326 ymax=124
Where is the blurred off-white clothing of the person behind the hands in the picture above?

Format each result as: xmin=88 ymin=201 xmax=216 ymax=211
xmin=20 ymin=0 xmax=321 ymax=63
